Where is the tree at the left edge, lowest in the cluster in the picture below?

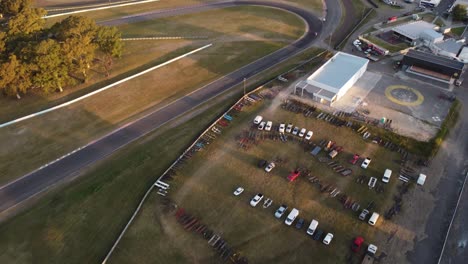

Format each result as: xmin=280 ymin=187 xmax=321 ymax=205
xmin=0 ymin=55 xmax=31 ymax=99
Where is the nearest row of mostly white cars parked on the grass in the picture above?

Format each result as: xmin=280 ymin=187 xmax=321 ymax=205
xmin=247 ymin=191 xmax=333 ymax=245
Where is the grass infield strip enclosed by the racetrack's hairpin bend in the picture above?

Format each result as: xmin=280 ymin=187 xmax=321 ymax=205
xmin=0 ymin=7 xmax=303 ymax=186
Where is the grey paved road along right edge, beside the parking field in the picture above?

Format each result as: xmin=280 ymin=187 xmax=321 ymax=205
xmin=407 ymin=80 xmax=468 ymax=264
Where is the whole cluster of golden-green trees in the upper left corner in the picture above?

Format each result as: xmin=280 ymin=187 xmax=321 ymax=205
xmin=0 ymin=0 xmax=123 ymax=99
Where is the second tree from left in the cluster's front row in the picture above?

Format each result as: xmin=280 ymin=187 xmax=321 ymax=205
xmin=31 ymin=39 xmax=70 ymax=94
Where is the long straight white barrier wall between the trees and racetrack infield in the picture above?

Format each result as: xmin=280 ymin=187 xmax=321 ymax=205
xmin=0 ymin=43 xmax=213 ymax=128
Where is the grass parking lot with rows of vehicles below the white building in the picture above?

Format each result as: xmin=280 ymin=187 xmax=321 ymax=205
xmin=165 ymin=89 xmax=410 ymax=263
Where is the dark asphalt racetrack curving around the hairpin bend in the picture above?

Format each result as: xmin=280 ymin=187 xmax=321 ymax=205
xmin=0 ymin=1 xmax=330 ymax=217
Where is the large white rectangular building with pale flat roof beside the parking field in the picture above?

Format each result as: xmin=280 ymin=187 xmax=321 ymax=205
xmin=294 ymin=52 xmax=369 ymax=105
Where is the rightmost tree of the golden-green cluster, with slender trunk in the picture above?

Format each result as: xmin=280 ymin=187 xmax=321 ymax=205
xmin=95 ymin=27 xmax=123 ymax=77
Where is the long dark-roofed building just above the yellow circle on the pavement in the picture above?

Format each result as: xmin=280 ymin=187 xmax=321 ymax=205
xmin=402 ymin=50 xmax=465 ymax=83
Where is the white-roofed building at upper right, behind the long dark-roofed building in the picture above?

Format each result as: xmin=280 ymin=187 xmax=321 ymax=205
xmin=392 ymin=20 xmax=444 ymax=43
